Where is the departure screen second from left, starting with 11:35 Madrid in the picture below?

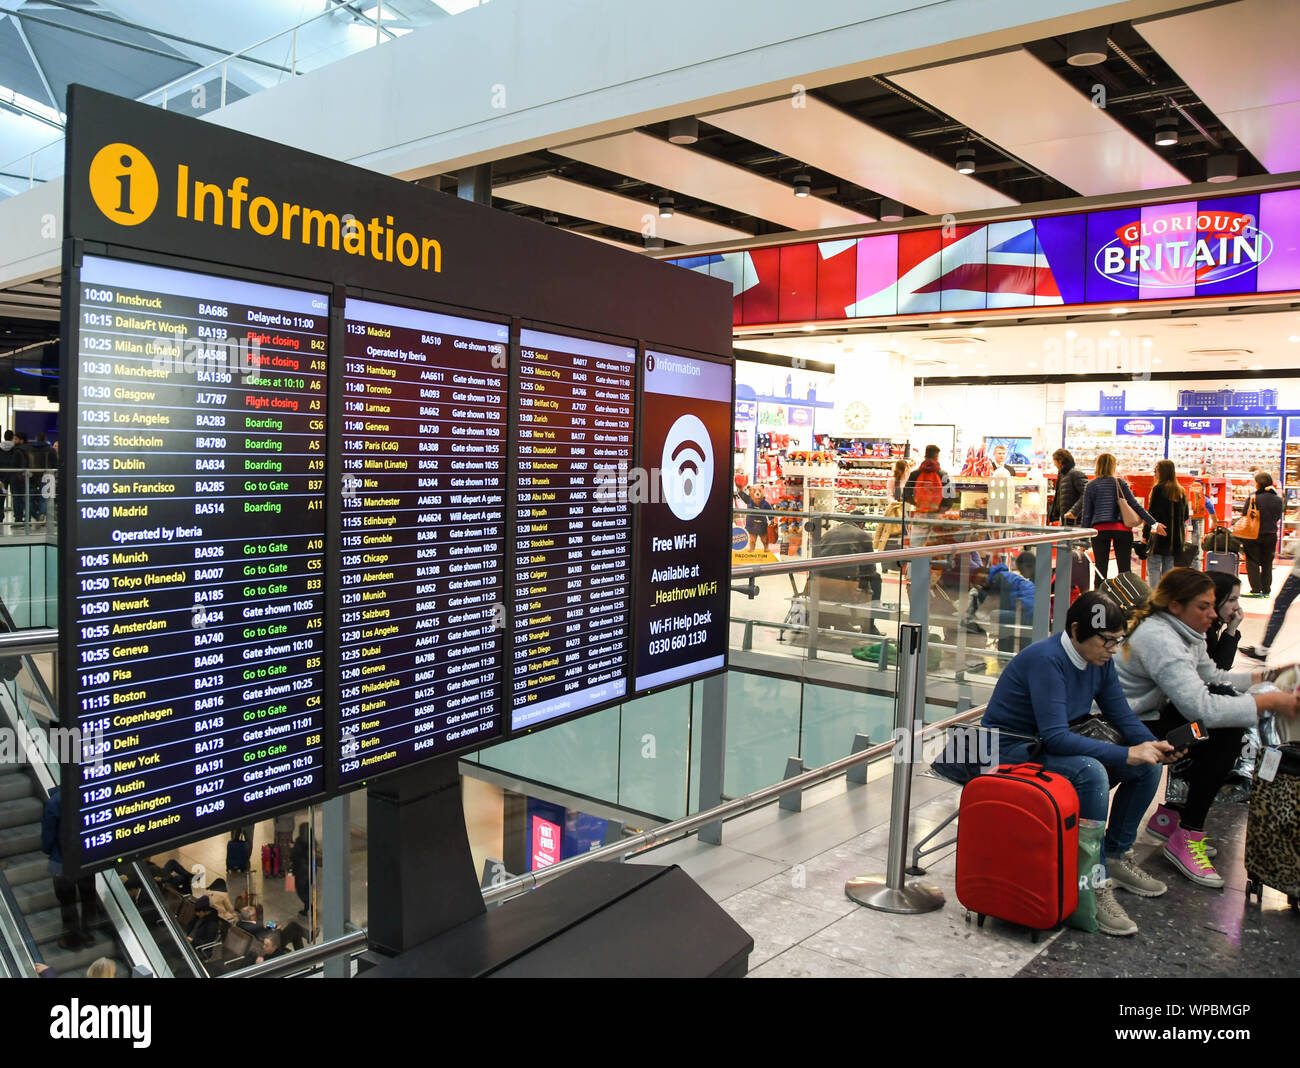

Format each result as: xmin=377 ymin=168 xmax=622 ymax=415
xmin=339 ymin=299 xmax=510 ymax=785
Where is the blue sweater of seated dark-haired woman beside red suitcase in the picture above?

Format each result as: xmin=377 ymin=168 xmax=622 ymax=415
xmin=984 ymin=634 xmax=1154 ymax=768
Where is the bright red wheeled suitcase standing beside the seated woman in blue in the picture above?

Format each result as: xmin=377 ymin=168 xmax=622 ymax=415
xmin=957 ymin=764 xmax=1079 ymax=942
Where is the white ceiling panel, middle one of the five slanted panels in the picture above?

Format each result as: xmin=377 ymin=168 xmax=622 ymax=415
xmin=703 ymin=96 xmax=1017 ymax=214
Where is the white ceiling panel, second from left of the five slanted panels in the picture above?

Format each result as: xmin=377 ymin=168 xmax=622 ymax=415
xmin=551 ymin=130 xmax=875 ymax=230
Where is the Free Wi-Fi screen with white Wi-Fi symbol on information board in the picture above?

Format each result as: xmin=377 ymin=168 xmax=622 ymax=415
xmin=636 ymin=351 xmax=733 ymax=690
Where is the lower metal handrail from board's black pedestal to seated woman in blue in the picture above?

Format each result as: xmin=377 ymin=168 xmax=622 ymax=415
xmin=484 ymin=704 xmax=987 ymax=904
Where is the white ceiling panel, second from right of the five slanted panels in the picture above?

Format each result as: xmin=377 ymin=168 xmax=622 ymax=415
xmin=889 ymin=49 xmax=1187 ymax=196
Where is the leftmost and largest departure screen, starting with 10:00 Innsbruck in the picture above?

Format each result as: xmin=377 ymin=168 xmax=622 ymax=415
xmin=66 ymin=256 xmax=329 ymax=864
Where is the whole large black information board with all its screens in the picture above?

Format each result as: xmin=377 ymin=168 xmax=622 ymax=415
xmin=57 ymin=86 xmax=732 ymax=873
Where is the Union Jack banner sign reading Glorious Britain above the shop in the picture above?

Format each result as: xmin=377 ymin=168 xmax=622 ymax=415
xmin=671 ymin=190 xmax=1300 ymax=325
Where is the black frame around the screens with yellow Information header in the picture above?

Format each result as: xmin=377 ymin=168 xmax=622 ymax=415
xmin=59 ymin=86 xmax=735 ymax=873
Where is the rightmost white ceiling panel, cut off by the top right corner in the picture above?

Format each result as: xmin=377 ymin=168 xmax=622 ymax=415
xmin=1138 ymin=0 xmax=1300 ymax=174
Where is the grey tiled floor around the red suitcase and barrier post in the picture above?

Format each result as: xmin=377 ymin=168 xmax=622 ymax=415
xmin=644 ymin=568 xmax=1300 ymax=978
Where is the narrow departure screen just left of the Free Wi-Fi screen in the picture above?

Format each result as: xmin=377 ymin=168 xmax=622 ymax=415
xmin=511 ymin=330 xmax=636 ymax=730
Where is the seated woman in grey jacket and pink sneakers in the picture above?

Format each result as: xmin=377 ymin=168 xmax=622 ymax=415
xmin=1115 ymin=568 xmax=1296 ymax=889
